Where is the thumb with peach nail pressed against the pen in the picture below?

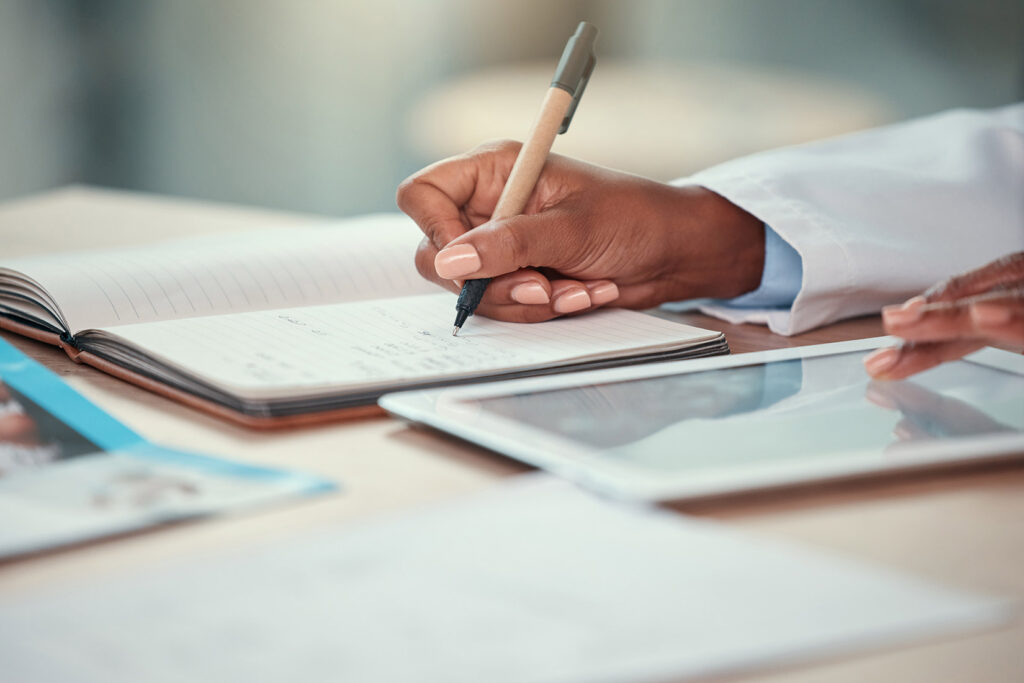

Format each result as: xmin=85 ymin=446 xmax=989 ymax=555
xmin=434 ymin=211 xmax=581 ymax=280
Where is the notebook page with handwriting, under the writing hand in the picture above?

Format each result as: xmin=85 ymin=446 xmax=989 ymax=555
xmin=97 ymin=293 xmax=717 ymax=398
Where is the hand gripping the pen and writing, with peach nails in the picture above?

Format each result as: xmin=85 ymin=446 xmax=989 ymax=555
xmin=397 ymin=142 xmax=764 ymax=323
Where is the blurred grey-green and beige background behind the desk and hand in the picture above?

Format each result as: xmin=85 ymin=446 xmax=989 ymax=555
xmin=0 ymin=0 xmax=1024 ymax=215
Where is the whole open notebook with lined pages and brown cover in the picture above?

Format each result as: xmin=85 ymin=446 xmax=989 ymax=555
xmin=0 ymin=214 xmax=728 ymax=426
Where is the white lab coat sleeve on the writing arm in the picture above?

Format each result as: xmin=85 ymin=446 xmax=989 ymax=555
xmin=676 ymin=103 xmax=1024 ymax=335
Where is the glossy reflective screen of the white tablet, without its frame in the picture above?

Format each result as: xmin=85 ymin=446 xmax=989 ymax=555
xmin=471 ymin=352 xmax=1024 ymax=472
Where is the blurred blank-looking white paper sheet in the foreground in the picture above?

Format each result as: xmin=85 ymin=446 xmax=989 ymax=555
xmin=0 ymin=475 xmax=1008 ymax=683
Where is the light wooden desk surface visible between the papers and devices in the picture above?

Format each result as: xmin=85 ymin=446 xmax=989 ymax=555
xmin=0 ymin=187 xmax=1024 ymax=683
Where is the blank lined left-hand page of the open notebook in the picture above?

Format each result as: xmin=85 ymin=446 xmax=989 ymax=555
xmin=0 ymin=214 xmax=437 ymax=332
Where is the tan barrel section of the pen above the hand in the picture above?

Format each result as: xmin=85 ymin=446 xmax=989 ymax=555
xmin=490 ymin=88 xmax=572 ymax=220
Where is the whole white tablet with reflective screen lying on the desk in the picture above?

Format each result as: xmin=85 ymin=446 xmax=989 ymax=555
xmin=380 ymin=337 xmax=1024 ymax=501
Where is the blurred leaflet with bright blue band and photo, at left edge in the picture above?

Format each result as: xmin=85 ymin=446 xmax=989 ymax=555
xmin=0 ymin=338 xmax=336 ymax=558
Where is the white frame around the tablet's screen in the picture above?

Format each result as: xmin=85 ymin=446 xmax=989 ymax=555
xmin=380 ymin=337 xmax=1024 ymax=501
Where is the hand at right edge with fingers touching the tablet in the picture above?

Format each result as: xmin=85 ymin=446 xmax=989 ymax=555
xmin=864 ymin=252 xmax=1024 ymax=380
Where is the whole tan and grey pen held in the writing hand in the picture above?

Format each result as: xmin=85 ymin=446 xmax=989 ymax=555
xmin=452 ymin=22 xmax=597 ymax=337
